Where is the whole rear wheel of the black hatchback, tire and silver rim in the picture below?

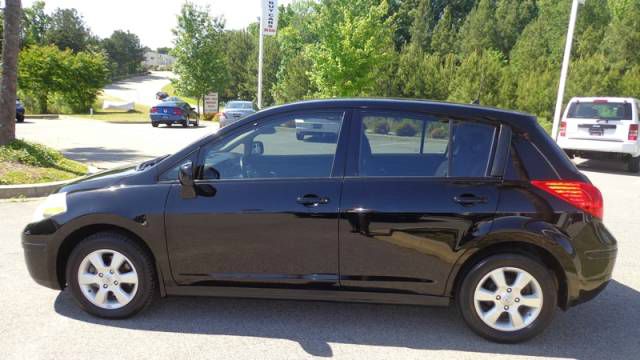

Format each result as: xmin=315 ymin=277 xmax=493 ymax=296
xmin=457 ymin=254 xmax=557 ymax=343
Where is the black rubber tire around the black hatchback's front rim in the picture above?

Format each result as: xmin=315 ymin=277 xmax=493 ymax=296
xmin=66 ymin=232 xmax=158 ymax=319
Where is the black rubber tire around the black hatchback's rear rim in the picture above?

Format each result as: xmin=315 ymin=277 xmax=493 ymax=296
xmin=456 ymin=254 xmax=558 ymax=343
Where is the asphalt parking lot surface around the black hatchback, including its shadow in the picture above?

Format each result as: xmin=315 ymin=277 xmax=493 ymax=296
xmin=0 ymin=120 xmax=640 ymax=360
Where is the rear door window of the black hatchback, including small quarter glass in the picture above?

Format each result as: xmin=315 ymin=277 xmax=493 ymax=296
xmin=358 ymin=112 xmax=496 ymax=177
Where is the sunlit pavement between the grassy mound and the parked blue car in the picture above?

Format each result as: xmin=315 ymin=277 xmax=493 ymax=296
xmin=16 ymin=119 xmax=217 ymax=168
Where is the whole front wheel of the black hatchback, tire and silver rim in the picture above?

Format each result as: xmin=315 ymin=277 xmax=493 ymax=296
xmin=66 ymin=232 xmax=157 ymax=319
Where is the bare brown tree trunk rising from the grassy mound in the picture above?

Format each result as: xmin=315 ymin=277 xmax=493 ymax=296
xmin=0 ymin=0 xmax=22 ymax=146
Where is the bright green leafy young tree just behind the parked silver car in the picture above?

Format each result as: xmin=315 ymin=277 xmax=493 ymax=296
xmin=171 ymin=2 xmax=229 ymax=114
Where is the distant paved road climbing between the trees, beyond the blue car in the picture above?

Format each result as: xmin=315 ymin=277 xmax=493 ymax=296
xmin=104 ymin=71 xmax=174 ymax=106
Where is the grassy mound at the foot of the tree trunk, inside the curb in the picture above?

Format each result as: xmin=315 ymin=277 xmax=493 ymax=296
xmin=0 ymin=140 xmax=88 ymax=185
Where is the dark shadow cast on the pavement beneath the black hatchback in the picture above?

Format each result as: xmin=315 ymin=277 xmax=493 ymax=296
xmin=54 ymin=281 xmax=640 ymax=359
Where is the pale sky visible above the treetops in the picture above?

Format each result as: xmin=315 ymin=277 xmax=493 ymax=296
xmin=22 ymin=0 xmax=292 ymax=49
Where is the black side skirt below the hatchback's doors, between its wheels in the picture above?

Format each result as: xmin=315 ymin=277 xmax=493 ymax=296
xmin=166 ymin=286 xmax=451 ymax=306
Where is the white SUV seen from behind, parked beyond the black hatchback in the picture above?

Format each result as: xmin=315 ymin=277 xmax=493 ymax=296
xmin=558 ymin=98 xmax=640 ymax=173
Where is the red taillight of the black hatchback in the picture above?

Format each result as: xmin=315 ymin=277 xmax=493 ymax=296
xmin=531 ymin=180 xmax=604 ymax=219
